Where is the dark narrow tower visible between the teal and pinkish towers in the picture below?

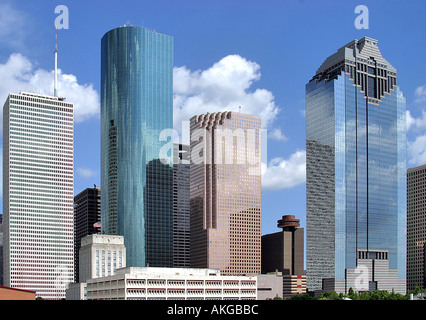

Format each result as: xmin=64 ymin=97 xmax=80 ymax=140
xmin=173 ymin=143 xmax=190 ymax=268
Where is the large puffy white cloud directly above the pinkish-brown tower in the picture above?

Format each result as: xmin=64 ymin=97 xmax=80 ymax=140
xmin=173 ymin=55 xmax=279 ymax=131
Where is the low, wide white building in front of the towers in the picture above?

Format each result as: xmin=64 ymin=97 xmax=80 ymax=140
xmin=87 ymin=267 xmax=257 ymax=300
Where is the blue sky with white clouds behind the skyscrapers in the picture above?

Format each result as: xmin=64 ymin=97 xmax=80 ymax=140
xmin=0 ymin=0 xmax=426 ymax=234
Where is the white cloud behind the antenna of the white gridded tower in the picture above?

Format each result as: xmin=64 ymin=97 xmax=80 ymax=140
xmin=0 ymin=53 xmax=100 ymax=123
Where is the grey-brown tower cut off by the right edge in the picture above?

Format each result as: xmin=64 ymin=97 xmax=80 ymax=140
xmin=407 ymin=165 xmax=426 ymax=290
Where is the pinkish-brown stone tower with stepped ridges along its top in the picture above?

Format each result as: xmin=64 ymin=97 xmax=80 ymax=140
xmin=190 ymin=112 xmax=261 ymax=275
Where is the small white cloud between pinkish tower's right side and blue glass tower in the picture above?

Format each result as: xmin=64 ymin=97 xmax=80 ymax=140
xmin=262 ymin=150 xmax=306 ymax=190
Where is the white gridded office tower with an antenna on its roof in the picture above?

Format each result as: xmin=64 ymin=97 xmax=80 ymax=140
xmin=3 ymin=92 xmax=74 ymax=299
